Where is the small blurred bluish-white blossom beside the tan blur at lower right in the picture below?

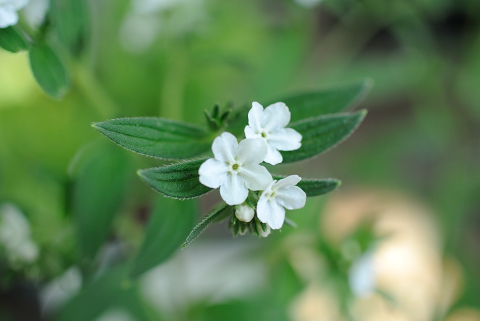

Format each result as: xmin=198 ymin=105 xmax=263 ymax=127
xmin=348 ymin=251 xmax=376 ymax=298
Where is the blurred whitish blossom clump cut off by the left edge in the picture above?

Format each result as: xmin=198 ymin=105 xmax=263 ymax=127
xmin=0 ymin=204 xmax=38 ymax=266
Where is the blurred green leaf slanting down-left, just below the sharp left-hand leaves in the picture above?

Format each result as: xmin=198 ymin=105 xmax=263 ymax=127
xmin=130 ymin=197 xmax=197 ymax=278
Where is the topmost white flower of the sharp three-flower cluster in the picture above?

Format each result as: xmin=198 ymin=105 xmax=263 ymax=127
xmin=245 ymin=101 xmax=302 ymax=165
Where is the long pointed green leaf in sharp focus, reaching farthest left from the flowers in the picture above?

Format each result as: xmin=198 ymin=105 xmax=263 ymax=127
xmin=92 ymin=117 xmax=212 ymax=159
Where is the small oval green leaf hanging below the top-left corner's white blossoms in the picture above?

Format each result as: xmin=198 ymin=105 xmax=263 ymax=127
xmin=30 ymin=44 xmax=69 ymax=98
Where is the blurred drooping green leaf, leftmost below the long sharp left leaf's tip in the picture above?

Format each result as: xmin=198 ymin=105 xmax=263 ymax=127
xmin=72 ymin=146 xmax=130 ymax=259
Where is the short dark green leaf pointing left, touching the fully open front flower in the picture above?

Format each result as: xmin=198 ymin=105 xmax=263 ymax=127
xmin=138 ymin=158 xmax=212 ymax=199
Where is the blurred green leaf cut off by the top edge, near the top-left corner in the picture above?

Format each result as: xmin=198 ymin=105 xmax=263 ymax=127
xmin=50 ymin=0 xmax=89 ymax=55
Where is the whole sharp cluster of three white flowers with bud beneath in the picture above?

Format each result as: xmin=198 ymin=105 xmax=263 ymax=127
xmin=198 ymin=102 xmax=306 ymax=236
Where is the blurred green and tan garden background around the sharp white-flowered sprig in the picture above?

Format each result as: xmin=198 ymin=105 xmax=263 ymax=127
xmin=0 ymin=0 xmax=480 ymax=321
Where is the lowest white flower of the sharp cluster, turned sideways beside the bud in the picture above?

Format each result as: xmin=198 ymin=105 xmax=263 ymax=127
xmin=257 ymin=175 xmax=307 ymax=230
